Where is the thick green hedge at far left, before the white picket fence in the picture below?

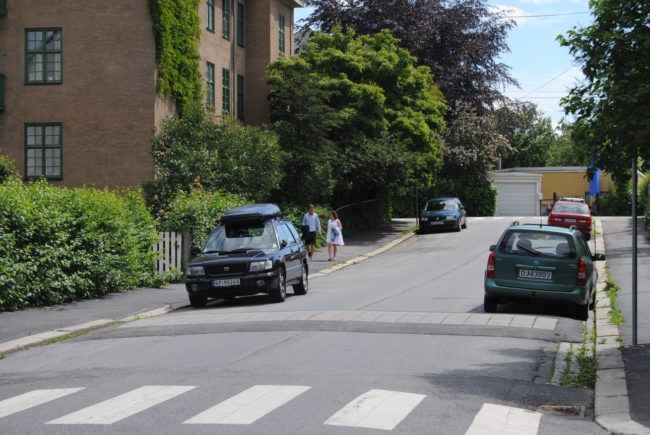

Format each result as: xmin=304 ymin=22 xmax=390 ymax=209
xmin=0 ymin=178 xmax=158 ymax=310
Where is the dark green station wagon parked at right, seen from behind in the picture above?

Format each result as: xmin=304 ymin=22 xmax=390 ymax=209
xmin=483 ymin=222 xmax=605 ymax=320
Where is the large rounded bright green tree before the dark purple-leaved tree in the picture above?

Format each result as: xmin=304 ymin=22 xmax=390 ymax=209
xmin=268 ymin=27 xmax=446 ymax=204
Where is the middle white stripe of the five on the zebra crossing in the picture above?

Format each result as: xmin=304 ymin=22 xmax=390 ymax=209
xmin=185 ymin=385 xmax=311 ymax=424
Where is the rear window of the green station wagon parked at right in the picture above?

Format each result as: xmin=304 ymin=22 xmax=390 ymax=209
xmin=499 ymin=230 xmax=576 ymax=258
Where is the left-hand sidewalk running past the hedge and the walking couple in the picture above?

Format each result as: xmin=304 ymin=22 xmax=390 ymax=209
xmin=0 ymin=218 xmax=415 ymax=354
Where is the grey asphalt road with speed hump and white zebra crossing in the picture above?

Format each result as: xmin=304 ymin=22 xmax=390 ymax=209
xmin=0 ymin=219 xmax=602 ymax=434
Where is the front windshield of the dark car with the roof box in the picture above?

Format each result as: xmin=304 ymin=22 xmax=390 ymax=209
xmin=203 ymin=222 xmax=278 ymax=252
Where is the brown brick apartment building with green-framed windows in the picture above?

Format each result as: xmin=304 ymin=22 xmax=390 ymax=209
xmin=0 ymin=0 xmax=302 ymax=187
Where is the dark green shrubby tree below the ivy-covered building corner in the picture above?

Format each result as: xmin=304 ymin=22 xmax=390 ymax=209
xmin=145 ymin=104 xmax=282 ymax=210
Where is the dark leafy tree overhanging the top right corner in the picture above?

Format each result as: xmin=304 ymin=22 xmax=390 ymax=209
xmin=558 ymin=0 xmax=650 ymax=177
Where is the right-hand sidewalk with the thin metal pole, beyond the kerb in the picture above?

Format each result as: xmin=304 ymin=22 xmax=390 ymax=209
xmin=596 ymin=217 xmax=650 ymax=433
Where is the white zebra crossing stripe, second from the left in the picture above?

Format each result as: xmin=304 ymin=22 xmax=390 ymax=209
xmin=47 ymin=385 xmax=196 ymax=424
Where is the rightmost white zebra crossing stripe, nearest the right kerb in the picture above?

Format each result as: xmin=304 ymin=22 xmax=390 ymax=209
xmin=465 ymin=403 xmax=542 ymax=435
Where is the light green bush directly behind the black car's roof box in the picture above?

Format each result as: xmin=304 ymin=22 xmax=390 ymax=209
xmin=160 ymin=184 xmax=247 ymax=246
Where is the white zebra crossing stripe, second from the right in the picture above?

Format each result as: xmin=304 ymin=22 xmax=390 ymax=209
xmin=324 ymin=390 xmax=426 ymax=430
